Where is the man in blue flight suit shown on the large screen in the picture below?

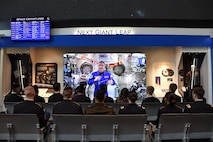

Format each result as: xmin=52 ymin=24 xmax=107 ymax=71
xmin=88 ymin=61 xmax=115 ymax=96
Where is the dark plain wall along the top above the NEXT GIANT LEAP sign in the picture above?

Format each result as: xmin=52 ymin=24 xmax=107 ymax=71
xmin=0 ymin=0 xmax=213 ymax=28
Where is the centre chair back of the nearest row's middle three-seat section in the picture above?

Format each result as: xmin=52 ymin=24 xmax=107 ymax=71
xmin=85 ymin=115 xmax=116 ymax=141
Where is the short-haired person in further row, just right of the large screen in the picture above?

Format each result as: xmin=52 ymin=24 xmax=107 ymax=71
xmin=142 ymin=86 xmax=160 ymax=105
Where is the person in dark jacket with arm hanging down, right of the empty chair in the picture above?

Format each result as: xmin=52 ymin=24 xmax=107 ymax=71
xmin=156 ymin=92 xmax=182 ymax=125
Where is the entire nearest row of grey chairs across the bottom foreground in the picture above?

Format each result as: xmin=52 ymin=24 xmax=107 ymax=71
xmin=0 ymin=113 xmax=213 ymax=142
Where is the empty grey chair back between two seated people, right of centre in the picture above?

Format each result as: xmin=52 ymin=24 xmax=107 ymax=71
xmin=143 ymin=102 xmax=161 ymax=122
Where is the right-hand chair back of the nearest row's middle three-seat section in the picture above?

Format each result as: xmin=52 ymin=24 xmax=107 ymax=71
xmin=116 ymin=114 xmax=147 ymax=142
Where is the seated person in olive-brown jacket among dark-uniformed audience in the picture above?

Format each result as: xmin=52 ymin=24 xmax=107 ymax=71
xmin=85 ymin=90 xmax=115 ymax=115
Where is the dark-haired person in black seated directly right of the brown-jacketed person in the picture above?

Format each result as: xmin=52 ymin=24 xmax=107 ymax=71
xmin=119 ymin=91 xmax=146 ymax=114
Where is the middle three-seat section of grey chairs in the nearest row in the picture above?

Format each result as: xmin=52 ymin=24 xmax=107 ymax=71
xmin=52 ymin=114 xmax=147 ymax=142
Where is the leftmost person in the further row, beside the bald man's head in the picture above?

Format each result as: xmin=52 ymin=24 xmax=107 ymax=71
xmin=4 ymin=84 xmax=24 ymax=102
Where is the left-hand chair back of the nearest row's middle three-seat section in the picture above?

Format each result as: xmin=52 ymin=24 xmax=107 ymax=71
xmin=52 ymin=114 xmax=84 ymax=142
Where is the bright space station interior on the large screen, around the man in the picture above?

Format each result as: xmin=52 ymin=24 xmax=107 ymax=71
xmin=64 ymin=53 xmax=146 ymax=100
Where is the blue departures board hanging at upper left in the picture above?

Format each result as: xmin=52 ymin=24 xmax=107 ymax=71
xmin=11 ymin=17 xmax=50 ymax=41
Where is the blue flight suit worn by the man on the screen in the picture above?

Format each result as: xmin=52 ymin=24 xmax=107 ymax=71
xmin=88 ymin=71 xmax=115 ymax=96
